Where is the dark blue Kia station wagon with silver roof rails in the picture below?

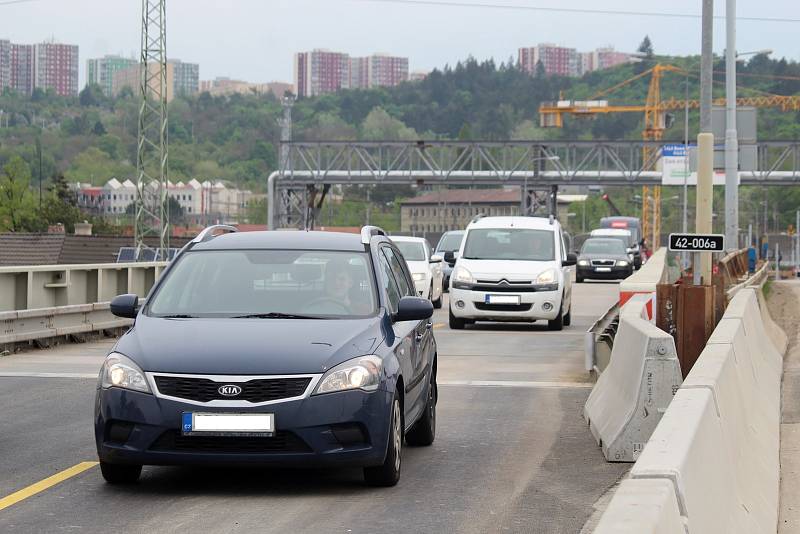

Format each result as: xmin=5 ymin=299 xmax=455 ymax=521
xmin=95 ymin=226 xmax=437 ymax=486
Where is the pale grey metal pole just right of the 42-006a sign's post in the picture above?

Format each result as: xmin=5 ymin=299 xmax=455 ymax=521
xmin=725 ymin=0 xmax=739 ymax=250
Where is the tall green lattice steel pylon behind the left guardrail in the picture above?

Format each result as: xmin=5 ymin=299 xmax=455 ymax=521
xmin=134 ymin=0 xmax=170 ymax=260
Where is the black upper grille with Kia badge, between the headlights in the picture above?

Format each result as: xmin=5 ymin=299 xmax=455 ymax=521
xmin=155 ymin=375 xmax=311 ymax=403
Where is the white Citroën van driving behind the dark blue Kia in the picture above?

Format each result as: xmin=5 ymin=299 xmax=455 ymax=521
xmin=445 ymin=217 xmax=577 ymax=330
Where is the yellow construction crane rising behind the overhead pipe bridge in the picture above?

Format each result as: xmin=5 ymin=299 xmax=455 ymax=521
xmin=539 ymin=63 xmax=800 ymax=250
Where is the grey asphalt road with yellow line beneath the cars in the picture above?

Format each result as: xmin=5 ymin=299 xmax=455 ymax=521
xmin=0 ymin=283 xmax=628 ymax=533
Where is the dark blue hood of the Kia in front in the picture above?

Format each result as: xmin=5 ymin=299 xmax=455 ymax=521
xmin=115 ymin=315 xmax=384 ymax=375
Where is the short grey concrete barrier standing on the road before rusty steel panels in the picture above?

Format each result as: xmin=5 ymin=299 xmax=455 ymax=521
xmin=583 ymin=295 xmax=681 ymax=462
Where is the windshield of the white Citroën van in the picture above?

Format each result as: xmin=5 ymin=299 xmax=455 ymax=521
xmin=464 ymin=228 xmax=555 ymax=261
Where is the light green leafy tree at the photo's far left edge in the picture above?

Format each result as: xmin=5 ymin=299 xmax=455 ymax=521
xmin=0 ymin=156 xmax=41 ymax=232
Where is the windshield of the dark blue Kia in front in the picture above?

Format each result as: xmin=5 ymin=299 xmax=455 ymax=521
xmin=147 ymin=250 xmax=376 ymax=318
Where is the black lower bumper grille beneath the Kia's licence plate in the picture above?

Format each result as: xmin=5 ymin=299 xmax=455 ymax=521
xmin=150 ymin=430 xmax=311 ymax=454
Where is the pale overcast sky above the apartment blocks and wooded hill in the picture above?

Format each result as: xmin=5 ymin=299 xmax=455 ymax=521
xmin=0 ymin=0 xmax=800 ymax=84
